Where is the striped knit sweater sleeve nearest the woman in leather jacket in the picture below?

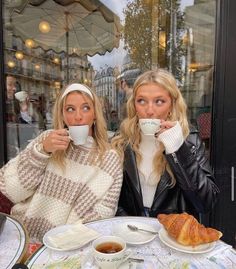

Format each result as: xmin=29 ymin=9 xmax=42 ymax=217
xmin=84 ymin=151 xmax=123 ymax=222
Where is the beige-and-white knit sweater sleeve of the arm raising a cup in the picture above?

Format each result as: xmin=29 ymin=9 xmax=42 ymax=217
xmin=0 ymin=131 xmax=49 ymax=203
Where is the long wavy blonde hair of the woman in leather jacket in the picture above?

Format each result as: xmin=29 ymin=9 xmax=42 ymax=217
xmin=112 ymin=68 xmax=189 ymax=185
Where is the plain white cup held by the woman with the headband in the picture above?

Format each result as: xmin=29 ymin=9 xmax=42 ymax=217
xmin=69 ymin=125 xmax=89 ymax=145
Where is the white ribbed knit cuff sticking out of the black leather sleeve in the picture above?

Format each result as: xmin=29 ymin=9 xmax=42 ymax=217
xmin=157 ymin=121 xmax=184 ymax=154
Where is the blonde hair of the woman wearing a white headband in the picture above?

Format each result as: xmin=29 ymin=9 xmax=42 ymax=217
xmin=52 ymin=85 xmax=109 ymax=167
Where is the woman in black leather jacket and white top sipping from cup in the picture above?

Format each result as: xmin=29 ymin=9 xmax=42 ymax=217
xmin=112 ymin=69 xmax=219 ymax=217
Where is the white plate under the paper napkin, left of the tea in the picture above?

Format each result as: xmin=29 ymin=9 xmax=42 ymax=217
xmin=43 ymin=224 xmax=97 ymax=251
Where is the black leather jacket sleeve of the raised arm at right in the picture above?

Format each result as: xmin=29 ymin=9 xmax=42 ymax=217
xmin=166 ymin=132 xmax=219 ymax=213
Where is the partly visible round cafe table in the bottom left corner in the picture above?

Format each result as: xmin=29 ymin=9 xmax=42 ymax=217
xmin=0 ymin=213 xmax=28 ymax=269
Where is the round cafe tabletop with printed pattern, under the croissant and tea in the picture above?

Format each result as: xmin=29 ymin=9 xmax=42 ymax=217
xmin=26 ymin=217 xmax=236 ymax=269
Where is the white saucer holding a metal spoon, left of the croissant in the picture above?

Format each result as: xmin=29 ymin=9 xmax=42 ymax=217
xmin=112 ymin=221 xmax=157 ymax=245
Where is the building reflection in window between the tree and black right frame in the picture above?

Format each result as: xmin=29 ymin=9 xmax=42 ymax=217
xmin=183 ymin=1 xmax=215 ymax=123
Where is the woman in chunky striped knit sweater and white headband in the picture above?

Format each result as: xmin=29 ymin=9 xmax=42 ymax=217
xmin=0 ymin=83 xmax=122 ymax=240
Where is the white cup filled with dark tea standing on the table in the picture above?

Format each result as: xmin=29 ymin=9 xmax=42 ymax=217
xmin=92 ymin=236 xmax=131 ymax=269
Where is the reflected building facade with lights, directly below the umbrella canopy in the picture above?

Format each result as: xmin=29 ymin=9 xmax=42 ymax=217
xmin=4 ymin=37 xmax=94 ymax=104
